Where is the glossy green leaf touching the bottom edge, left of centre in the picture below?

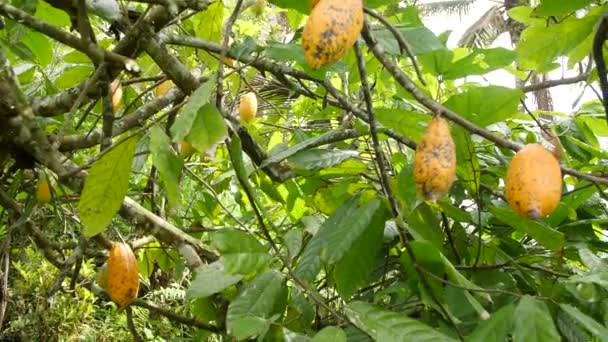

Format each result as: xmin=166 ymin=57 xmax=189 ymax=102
xmin=226 ymin=270 xmax=287 ymax=340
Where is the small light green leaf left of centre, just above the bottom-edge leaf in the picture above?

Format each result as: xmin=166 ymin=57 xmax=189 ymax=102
xmin=211 ymin=229 xmax=270 ymax=274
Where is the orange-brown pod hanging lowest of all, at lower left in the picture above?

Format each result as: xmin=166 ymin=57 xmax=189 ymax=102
xmin=107 ymin=243 xmax=139 ymax=308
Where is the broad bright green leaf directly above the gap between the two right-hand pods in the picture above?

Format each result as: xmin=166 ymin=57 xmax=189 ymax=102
xmin=445 ymin=86 xmax=523 ymax=127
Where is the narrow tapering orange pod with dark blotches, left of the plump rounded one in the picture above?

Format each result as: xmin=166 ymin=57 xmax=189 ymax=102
xmin=414 ymin=116 xmax=456 ymax=201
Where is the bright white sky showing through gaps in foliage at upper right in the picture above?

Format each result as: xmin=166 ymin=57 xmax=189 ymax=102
xmin=423 ymin=0 xmax=599 ymax=113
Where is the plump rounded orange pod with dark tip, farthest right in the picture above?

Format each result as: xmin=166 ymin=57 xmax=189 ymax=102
xmin=505 ymin=144 xmax=562 ymax=218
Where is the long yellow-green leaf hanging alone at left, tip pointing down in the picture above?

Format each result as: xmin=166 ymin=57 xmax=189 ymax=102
xmin=78 ymin=137 xmax=137 ymax=237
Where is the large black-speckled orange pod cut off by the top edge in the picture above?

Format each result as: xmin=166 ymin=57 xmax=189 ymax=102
xmin=302 ymin=0 xmax=363 ymax=69
